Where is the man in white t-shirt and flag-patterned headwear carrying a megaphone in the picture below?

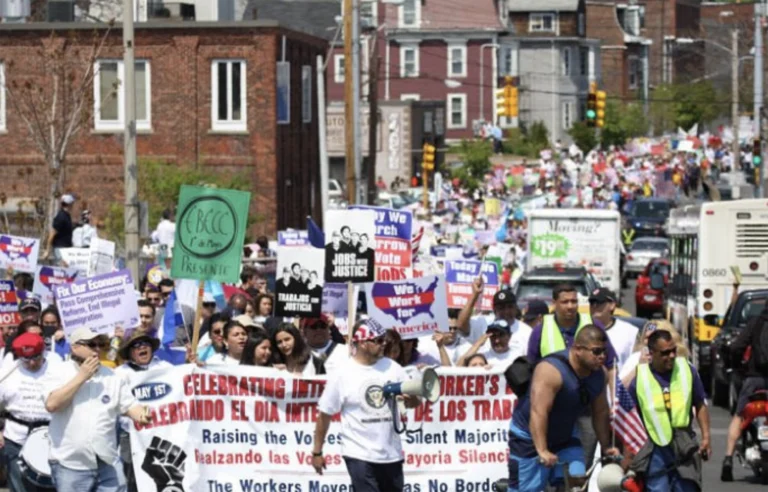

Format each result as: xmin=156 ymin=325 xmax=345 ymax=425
xmin=312 ymin=319 xmax=420 ymax=492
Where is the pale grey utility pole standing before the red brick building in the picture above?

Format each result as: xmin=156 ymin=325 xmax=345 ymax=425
xmin=122 ymin=0 xmax=141 ymax=285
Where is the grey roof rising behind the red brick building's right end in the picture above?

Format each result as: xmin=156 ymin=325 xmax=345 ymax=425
xmin=243 ymin=0 xmax=341 ymax=40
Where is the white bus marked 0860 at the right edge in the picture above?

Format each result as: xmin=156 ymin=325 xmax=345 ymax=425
xmin=667 ymin=199 xmax=768 ymax=385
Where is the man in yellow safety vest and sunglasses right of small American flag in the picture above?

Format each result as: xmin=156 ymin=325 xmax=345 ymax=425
xmin=629 ymin=330 xmax=712 ymax=492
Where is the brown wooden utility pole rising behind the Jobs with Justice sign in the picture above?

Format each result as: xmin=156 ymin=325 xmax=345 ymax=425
xmin=343 ymin=0 xmax=358 ymax=205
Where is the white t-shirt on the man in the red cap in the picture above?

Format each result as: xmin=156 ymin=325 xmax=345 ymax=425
xmin=0 ymin=361 xmax=52 ymax=446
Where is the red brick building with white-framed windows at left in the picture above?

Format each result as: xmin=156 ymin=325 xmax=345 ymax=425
xmin=0 ymin=20 xmax=327 ymax=235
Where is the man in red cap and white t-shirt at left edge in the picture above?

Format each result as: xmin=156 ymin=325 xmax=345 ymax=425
xmin=0 ymin=333 xmax=58 ymax=492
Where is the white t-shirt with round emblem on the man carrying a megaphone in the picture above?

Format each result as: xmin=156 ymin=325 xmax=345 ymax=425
xmin=317 ymin=357 xmax=408 ymax=463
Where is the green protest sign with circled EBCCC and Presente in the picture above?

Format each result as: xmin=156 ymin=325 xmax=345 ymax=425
xmin=171 ymin=186 xmax=251 ymax=283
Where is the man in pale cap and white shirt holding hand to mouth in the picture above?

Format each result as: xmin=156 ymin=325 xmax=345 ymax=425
xmin=42 ymin=327 xmax=151 ymax=492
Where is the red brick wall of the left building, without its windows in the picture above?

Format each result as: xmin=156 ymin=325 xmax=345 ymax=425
xmin=0 ymin=26 xmax=325 ymax=238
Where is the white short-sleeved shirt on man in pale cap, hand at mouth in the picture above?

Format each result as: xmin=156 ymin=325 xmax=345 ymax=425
xmin=43 ymin=360 xmax=136 ymax=470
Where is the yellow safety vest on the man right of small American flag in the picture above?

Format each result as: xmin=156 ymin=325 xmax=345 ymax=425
xmin=635 ymin=357 xmax=693 ymax=446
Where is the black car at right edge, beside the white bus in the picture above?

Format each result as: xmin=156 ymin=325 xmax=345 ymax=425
xmin=709 ymin=289 xmax=768 ymax=410
